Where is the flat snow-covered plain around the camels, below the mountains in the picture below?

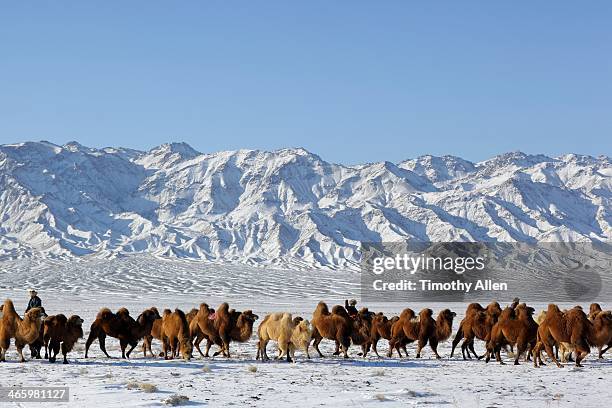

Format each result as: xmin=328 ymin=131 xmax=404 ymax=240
xmin=0 ymin=257 xmax=612 ymax=407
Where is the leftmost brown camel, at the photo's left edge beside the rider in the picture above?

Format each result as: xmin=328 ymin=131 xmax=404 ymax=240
xmin=0 ymin=299 xmax=46 ymax=363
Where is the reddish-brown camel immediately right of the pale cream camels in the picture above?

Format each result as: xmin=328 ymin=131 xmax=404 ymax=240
xmin=311 ymin=302 xmax=353 ymax=358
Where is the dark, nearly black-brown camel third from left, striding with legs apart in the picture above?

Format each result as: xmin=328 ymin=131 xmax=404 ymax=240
xmin=85 ymin=307 xmax=159 ymax=358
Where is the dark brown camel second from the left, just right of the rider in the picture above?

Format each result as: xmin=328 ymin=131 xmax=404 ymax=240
xmin=43 ymin=314 xmax=83 ymax=364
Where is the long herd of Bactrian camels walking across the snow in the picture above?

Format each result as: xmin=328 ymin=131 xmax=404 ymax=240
xmin=0 ymin=299 xmax=612 ymax=367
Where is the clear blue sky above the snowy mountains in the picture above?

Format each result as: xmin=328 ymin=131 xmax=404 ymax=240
xmin=0 ymin=1 xmax=612 ymax=163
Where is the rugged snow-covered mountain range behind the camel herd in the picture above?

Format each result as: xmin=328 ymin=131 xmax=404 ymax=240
xmin=0 ymin=142 xmax=612 ymax=268
